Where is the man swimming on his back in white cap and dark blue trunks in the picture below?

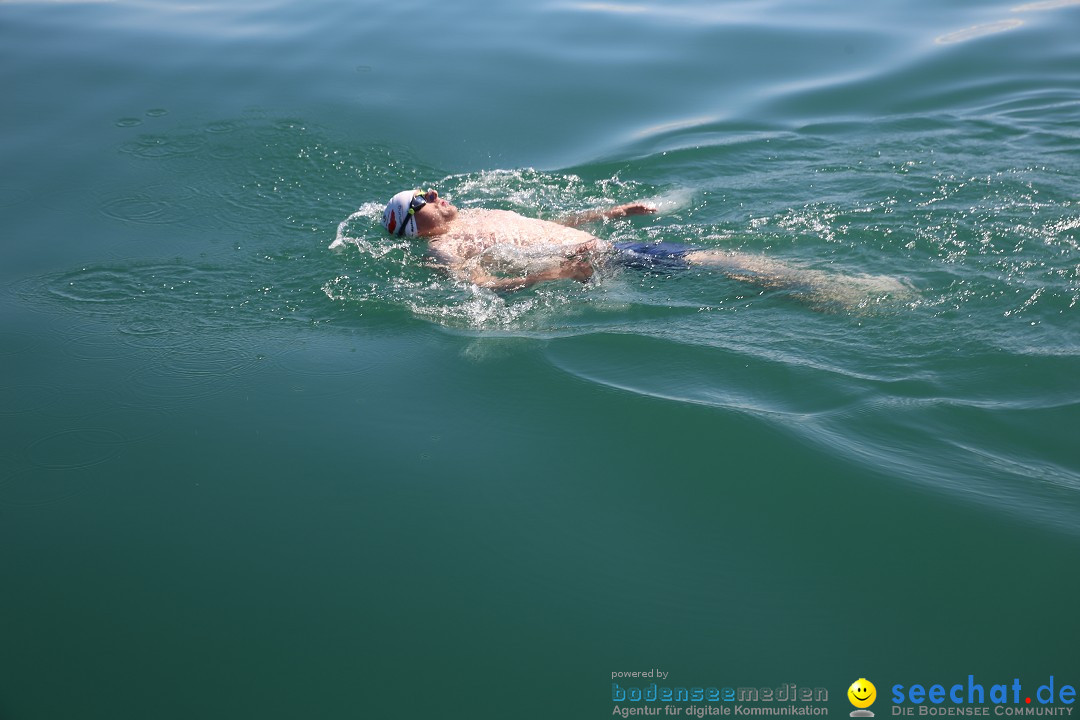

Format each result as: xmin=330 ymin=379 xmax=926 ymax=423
xmin=382 ymin=190 xmax=912 ymax=305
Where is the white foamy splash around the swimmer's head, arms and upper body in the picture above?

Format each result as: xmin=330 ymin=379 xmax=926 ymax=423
xmin=322 ymin=168 xmax=652 ymax=332
